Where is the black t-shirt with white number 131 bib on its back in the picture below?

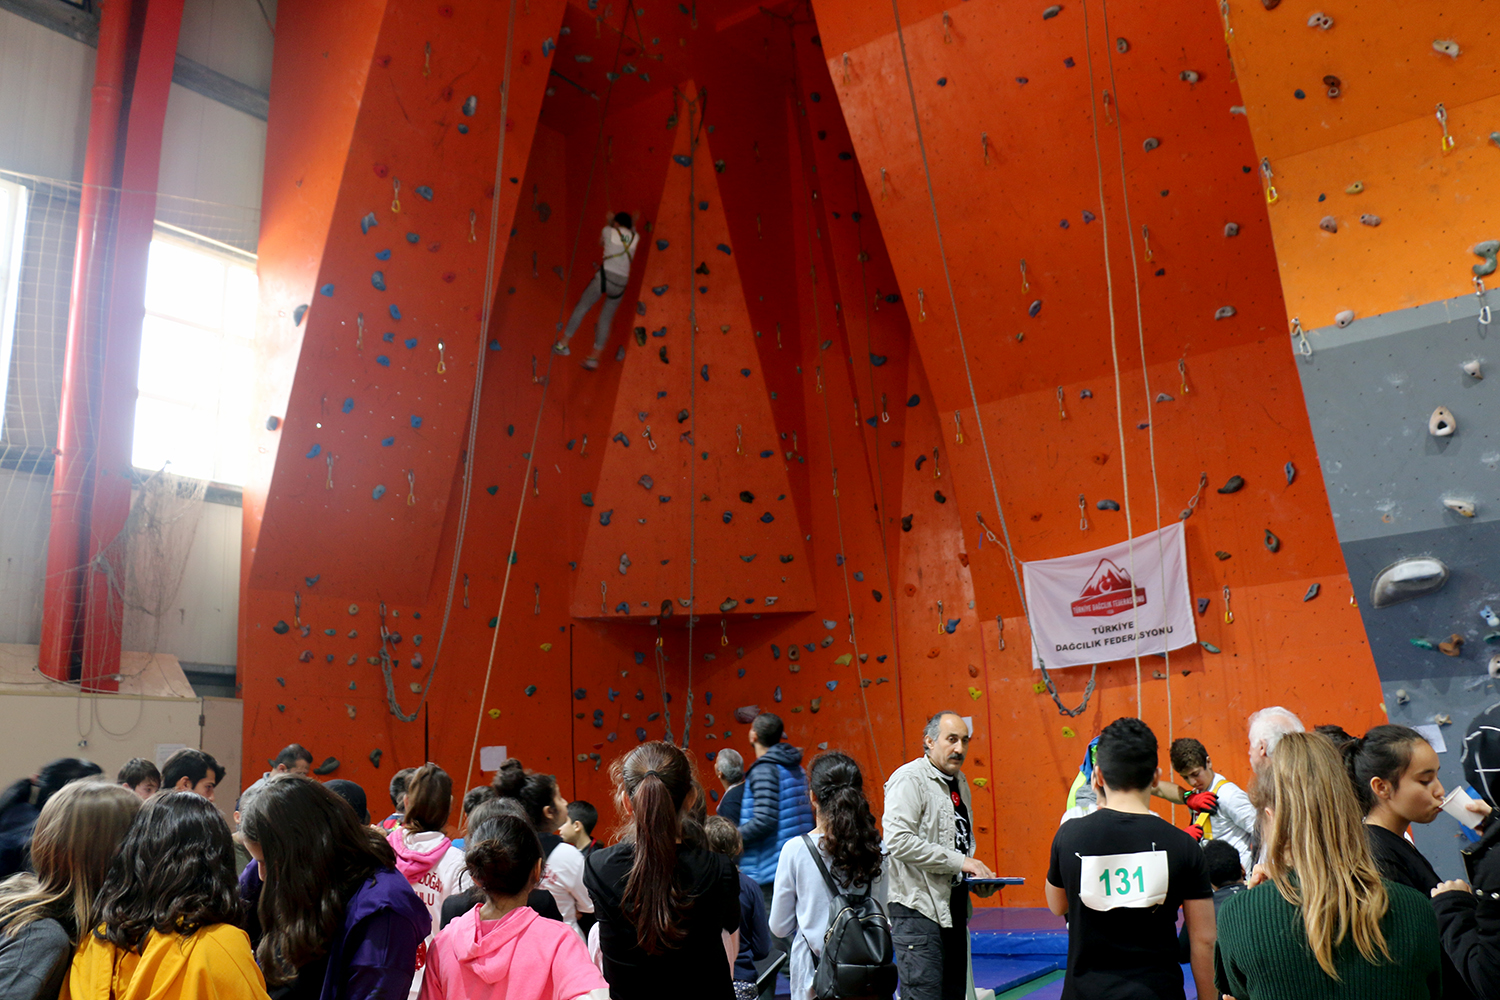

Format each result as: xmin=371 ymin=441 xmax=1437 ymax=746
xmin=1047 ymin=808 xmax=1214 ymax=1000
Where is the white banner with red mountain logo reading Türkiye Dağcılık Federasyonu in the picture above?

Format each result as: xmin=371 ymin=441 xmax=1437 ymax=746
xmin=1022 ymin=522 xmax=1199 ymax=667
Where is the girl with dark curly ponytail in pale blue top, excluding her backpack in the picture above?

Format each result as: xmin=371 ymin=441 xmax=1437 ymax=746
xmin=771 ymin=750 xmax=885 ymax=1000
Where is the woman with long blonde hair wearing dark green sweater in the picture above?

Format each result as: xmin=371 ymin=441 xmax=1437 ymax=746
xmin=1214 ymin=733 xmax=1443 ymax=1000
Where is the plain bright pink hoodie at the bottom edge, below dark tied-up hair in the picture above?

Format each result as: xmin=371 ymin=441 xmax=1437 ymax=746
xmin=422 ymin=906 xmax=608 ymax=1000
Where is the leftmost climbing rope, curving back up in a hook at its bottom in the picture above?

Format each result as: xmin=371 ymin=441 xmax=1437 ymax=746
xmin=380 ymin=0 xmax=530 ymax=728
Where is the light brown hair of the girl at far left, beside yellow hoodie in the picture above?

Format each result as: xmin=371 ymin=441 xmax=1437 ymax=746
xmin=0 ymin=778 xmax=141 ymax=942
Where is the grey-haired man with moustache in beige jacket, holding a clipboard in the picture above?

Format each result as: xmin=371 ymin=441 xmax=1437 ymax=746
xmin=884 ymin=712 xmax=995 ymax=1000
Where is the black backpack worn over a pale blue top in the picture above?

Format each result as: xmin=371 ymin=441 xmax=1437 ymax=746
xmin=803 ymin=834 xmax=896 ymax=1000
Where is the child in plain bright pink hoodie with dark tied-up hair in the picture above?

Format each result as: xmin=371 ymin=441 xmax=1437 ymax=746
xmin=422 ymin=814 xmax=609 ymax=1000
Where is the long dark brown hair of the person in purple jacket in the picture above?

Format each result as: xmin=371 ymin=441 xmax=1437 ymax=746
xmin=240 ymin=774 xmax=396 ymax=987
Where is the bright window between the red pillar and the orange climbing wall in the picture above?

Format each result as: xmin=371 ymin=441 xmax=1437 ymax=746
xmin=132 ymin=226 xmax=258 ymax=486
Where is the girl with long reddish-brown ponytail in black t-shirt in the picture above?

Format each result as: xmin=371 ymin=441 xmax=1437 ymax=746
xmin=584 ymin=742 xmax=740 ymax=1000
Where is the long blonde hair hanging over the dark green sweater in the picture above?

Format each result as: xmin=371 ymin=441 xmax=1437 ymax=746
xmin=1256 ymin=733 xmax=1391 ymax=981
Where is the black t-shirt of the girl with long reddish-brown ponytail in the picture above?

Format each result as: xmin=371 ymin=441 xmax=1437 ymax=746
xmin=584 ymin=844 xmax=740 ymax=1000
